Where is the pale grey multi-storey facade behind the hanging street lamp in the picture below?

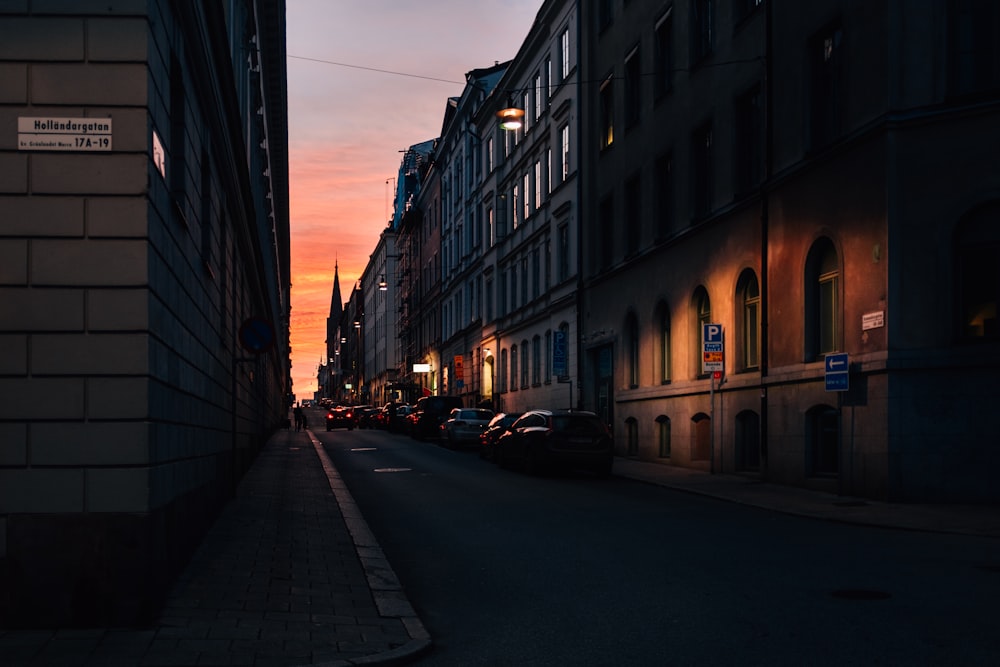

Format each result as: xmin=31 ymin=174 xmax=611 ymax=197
xmin=474 ymin=1 xmax=581 ymax=412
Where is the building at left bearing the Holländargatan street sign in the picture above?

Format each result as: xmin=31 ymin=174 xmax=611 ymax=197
xmin=0 ymin=0 xmax=291 ymax=626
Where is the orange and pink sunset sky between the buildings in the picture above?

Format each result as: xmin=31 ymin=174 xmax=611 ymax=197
xmin=287 ymin=0 xmax=542 ymax=400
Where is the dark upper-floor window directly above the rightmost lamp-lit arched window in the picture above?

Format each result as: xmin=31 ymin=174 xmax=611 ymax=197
xmin=808 ymin=25 xmax=845 ymax=150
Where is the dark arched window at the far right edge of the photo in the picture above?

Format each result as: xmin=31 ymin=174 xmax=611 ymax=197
xmin=955 ymin=202 xmax=1000 ymax=340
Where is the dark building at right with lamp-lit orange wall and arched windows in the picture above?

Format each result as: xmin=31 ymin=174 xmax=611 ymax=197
xmin=581 ymin=0 xmax=1000 ymax=502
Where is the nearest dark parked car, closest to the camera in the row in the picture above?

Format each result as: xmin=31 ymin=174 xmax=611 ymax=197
xmin=496 ymin=410 xmax=614 ymax=477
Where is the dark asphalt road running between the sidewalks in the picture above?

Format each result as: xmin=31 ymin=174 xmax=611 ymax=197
xmin=313 ymin=426 xmax=1000 ymax=666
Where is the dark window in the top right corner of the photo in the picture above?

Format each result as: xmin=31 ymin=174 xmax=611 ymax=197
xmin=948 ymin=0 xmax=1000 ymax=95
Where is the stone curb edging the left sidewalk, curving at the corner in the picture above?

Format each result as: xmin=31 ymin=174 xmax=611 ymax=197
xmin=306 ymin=430 xmax=432 ymax=667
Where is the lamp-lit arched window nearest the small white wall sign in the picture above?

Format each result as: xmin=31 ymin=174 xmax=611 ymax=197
xmin=805 ymin=238 xmax=840 ymax=361
